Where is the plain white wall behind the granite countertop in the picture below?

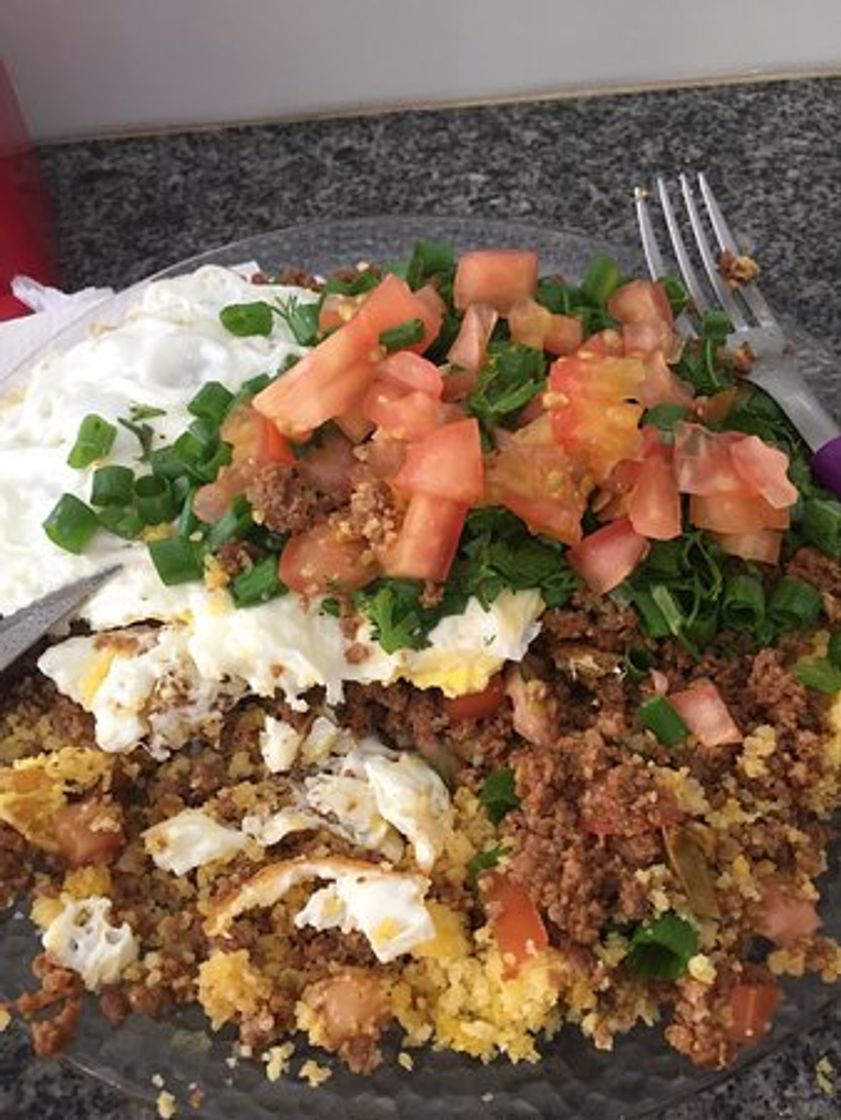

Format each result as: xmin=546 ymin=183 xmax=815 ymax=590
xmin=0 ymin=0 xmax=841 ymax=138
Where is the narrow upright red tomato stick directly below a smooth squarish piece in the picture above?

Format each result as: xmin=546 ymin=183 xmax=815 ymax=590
xmin=385 ymin=494 xmax=467 ymax=584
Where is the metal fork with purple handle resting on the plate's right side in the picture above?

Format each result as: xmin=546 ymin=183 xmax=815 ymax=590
xmin=635 ymin=172 xmax=841 ymax=497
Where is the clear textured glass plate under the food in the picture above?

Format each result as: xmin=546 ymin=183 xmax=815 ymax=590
xmin=0 ymin=217 xmax=841 ymax=1120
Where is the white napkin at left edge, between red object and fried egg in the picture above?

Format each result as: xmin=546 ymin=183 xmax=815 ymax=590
xmin=0 ymin=277 xmax=113 ymax=385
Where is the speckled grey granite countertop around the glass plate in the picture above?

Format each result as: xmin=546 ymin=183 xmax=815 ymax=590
xmin=0 ymin=78 xmax=841 ymax=1120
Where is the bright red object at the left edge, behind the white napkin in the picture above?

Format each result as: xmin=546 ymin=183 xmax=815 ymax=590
xmin=0 ymin=63 xmax=56 ymax=319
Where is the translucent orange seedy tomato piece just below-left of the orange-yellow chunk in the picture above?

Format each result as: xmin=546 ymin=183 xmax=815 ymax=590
xmin=485 ymin=440 xmax=591 ymax=544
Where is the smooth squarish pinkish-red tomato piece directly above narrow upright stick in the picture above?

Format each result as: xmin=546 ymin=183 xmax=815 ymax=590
xmin=394 ymin=418 xmax=485 ymax=505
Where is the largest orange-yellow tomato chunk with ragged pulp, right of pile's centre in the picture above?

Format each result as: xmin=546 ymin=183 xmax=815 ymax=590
xmin=544 ymin=355 xmax=645 ymax=483
